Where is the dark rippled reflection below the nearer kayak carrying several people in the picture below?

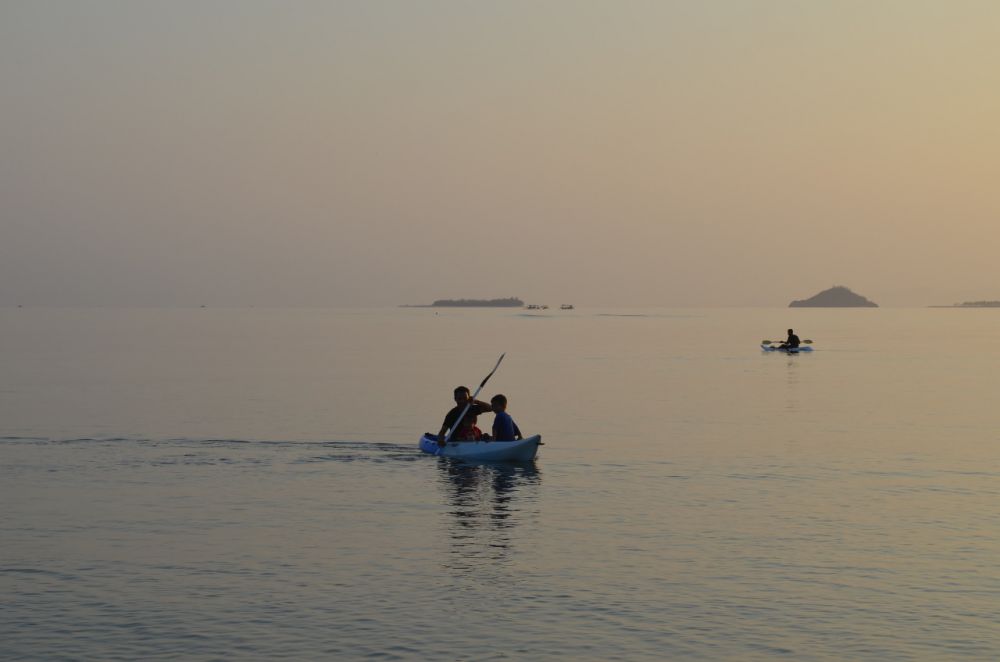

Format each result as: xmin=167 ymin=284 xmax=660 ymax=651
xmin=438 ymin=458 xmax=541 ymax=570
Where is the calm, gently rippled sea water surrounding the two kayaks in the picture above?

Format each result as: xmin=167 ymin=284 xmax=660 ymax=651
xmin=0 ymin=308 xmax=1000 ymax=660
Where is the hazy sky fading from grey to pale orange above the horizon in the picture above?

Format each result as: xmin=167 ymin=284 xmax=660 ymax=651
xmin=0 ymin=0 xmax=1000 ymax=306
